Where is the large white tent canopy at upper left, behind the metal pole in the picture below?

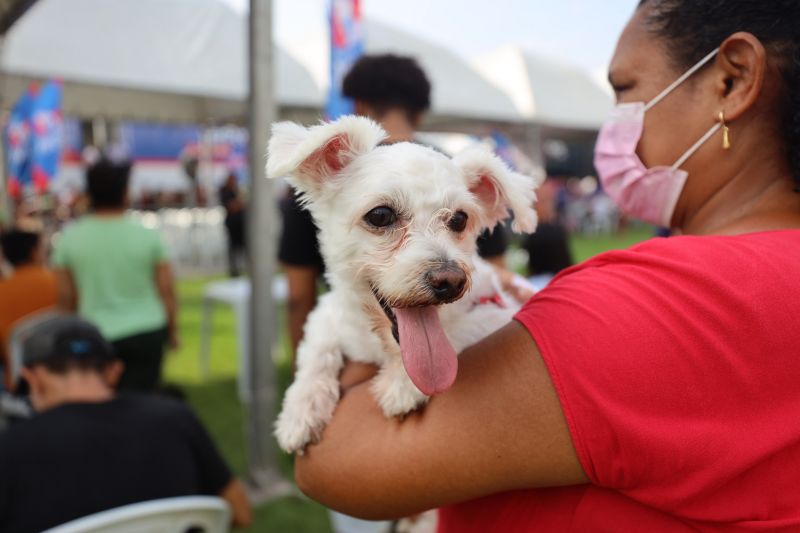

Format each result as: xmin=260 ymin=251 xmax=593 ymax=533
xmin=1 ymin=0 xmax=323 ymax=122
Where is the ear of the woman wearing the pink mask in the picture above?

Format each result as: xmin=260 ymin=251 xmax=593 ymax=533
xmin=715 ymin=32 xmax=767 ymax=121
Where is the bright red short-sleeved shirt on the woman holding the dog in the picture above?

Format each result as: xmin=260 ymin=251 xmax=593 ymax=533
xmin=439 ymin=231 xmax=800 ymax=533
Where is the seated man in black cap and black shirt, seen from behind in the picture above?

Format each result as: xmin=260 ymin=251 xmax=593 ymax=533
xmin=0 ymin=316 xmax=250 ymax=533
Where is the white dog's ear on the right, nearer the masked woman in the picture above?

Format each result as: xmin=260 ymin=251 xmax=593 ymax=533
xmin=453 ymin=148 xmax=539 ymax=233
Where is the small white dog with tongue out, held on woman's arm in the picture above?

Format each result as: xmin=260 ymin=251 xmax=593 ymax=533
xmin=267 ymin=116 xmax=538 ymax=452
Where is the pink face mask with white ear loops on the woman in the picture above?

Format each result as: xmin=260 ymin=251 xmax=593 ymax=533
xmin=594 ymin=48 xmax=722 ymax=226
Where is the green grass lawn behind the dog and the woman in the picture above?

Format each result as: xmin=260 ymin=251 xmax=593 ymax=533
xmin=165 ymin=228 xmax=652 ymax=533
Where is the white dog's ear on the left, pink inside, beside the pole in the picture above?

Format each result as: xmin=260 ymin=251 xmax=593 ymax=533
xmin=267 ymin=115 xmax=386 ymax=193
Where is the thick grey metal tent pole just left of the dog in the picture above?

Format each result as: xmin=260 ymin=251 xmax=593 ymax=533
xmin=246 ymin=0 xmax=289 ymax=502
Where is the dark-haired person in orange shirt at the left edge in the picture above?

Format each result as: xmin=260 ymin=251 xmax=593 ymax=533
xmin=0 ymin=229 xmax=58 ymax=389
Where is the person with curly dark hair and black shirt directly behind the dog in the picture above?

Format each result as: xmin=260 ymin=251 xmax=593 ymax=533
xmin=278 ymin=54 xmax=507 ymax=358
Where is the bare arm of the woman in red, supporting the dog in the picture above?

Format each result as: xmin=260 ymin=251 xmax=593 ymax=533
xmin=295 ymin=322 xmax=588 ymax=519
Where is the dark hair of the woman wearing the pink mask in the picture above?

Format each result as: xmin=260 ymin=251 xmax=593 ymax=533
xmin=639 ymin=0 xmax=800 ymax=188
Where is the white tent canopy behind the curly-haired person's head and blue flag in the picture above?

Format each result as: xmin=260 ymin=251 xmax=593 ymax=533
xmin=287 ymin=20 xmax=524 ymax=127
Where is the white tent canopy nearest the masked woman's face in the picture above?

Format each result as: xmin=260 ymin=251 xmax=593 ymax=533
xmin=474 ymin=46 xmax=613 ymax=130
